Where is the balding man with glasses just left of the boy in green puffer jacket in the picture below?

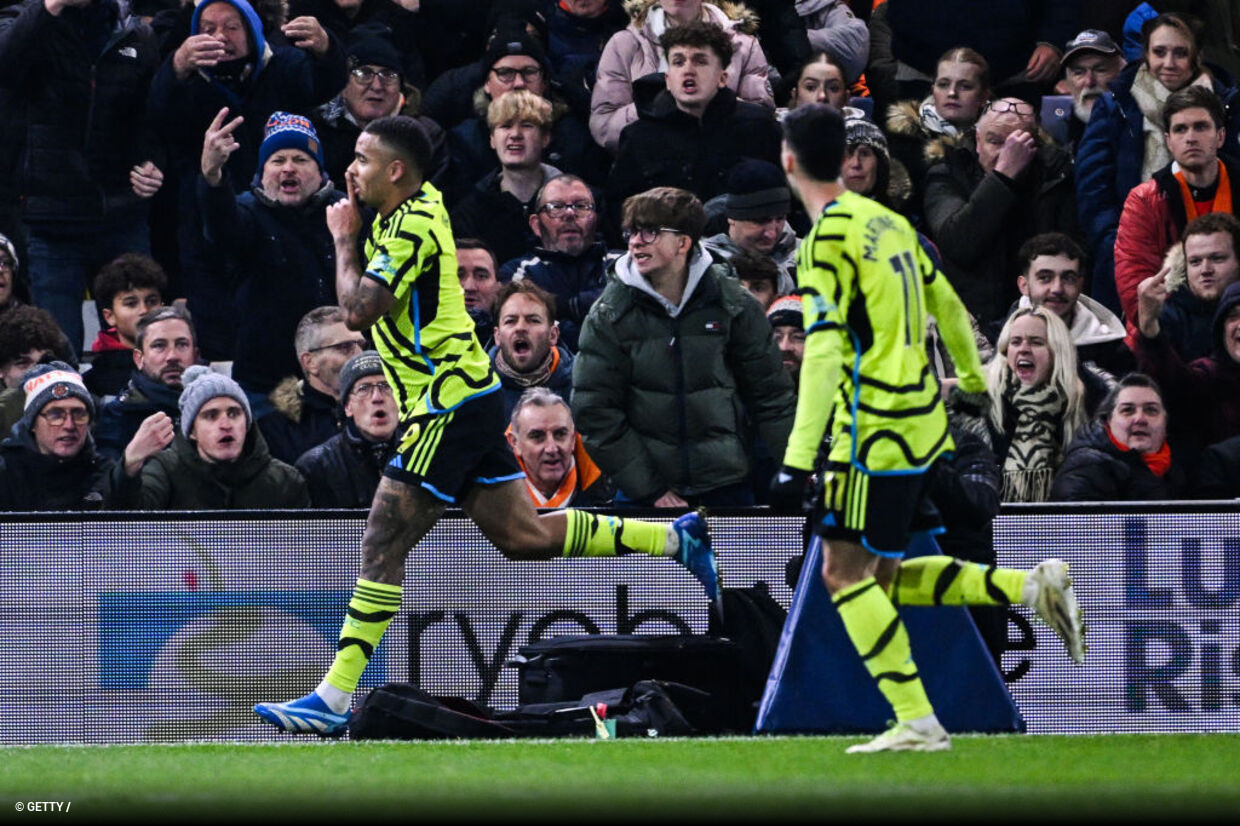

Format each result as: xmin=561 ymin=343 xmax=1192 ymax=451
xmin=500 ymin=175 xmax=620 ymax=351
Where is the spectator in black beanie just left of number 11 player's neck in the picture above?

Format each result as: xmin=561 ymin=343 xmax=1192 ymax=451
xmin=702 ymin=160 xmax=800 ymax=295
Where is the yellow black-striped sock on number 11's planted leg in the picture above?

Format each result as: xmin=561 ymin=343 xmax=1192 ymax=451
xmin=831 ymin=577 xmax=934 ymax=722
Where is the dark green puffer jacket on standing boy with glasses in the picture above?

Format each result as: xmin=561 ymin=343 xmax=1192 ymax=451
xmin=573 ymin=251 xmax=796 ymax=500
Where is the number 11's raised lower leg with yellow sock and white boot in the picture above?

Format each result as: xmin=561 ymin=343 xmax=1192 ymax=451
xmin=888 ymin=545 xmax=1085 ymax=662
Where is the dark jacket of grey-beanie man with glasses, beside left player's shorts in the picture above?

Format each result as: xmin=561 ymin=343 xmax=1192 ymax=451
xmin=295 ymin=419 xmax=396 ymax=507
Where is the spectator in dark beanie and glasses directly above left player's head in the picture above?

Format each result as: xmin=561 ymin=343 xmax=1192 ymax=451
xmin=311 ymin=24 xmax=448 ymax=189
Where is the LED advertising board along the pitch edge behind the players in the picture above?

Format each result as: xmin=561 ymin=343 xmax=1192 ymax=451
xmin=0 ymin=502 xmax=1240 ymax=744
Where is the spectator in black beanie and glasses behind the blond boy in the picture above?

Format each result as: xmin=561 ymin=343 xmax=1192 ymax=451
xmin=444 ymin=31 xmax=609 ymax=207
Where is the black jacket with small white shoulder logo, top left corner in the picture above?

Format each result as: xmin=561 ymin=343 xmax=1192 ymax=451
xmin=0 ymin=0 xmax=162 ymax=223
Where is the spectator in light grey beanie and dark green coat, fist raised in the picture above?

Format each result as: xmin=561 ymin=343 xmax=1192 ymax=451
xmin=113 ymin=365 xmax=310 ymax=511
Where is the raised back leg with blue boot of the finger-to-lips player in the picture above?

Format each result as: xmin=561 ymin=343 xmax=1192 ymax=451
xmin=461 ymin=476 xmax=719 ymax=602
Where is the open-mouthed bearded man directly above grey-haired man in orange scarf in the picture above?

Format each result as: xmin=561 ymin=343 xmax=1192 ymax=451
xmin=490 ymin=280 xmax=573 ymax=417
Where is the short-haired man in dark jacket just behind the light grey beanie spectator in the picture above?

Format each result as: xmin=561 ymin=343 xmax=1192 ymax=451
xmin=94 ymin=304 xmax=198 ymax=459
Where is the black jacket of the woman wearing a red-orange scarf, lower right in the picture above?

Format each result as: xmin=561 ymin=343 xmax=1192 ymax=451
xmin=1050 ymin=422 xmax=1185 ymax=502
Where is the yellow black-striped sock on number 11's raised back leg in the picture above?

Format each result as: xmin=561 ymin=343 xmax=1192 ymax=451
xmin=888 ymin=557 xmax=1029 ymax=605
